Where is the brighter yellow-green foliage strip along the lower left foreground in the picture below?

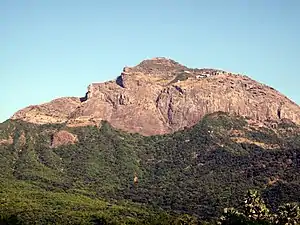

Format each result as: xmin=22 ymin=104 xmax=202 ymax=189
xmin=0 ymin=181 xmax=177 ymax=224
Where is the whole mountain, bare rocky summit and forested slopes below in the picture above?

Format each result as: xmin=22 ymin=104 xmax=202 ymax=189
xmin=0 ymin=58 xmax=300 ymax=224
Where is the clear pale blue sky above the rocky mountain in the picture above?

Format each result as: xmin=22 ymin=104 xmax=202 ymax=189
xmin=0 ymin=0 xmax=300 ymax=121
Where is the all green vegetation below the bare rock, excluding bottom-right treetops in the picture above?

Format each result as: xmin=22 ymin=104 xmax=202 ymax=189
xmin=0 ymin=113 xmax=300 ymax=224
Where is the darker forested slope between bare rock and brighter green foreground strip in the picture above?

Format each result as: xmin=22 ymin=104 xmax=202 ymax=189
xmin=0 ymin=112 xmax=300 ymax=223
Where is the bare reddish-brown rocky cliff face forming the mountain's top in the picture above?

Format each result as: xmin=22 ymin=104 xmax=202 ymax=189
xmin=12 ymin=58 xmax=300 ymax=135
